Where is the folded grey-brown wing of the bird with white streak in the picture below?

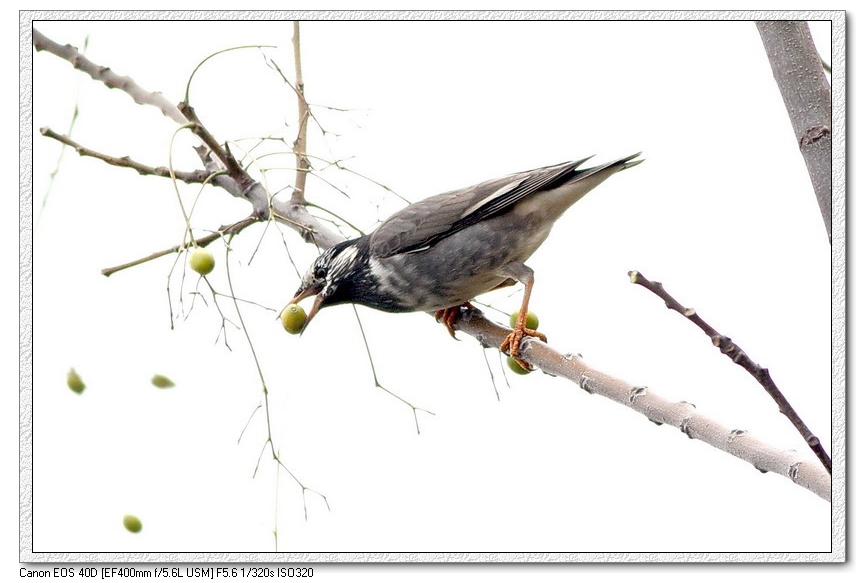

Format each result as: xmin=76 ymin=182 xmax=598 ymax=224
xmin=370 ymin=156 xmax=634 ymax=257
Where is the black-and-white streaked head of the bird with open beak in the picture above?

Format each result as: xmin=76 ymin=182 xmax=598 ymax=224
xmin=290 ymin=239 xmax=365 ymax=330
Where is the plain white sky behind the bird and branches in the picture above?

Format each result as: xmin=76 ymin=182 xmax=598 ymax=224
xmin=25 ymin=16 xmax=831 ymax=553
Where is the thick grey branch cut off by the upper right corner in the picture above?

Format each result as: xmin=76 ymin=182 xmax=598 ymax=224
xmin=757 ymin=21 xmax=832 ymax=241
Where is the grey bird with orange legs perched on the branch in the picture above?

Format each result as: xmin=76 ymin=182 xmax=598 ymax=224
xmin=289 ymin=153 xmax=643 ymax=370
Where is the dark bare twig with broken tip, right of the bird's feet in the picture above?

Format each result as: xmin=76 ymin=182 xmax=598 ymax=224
xmin=628 ymin=271 xmax=832 ymax=474
